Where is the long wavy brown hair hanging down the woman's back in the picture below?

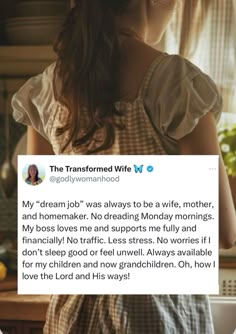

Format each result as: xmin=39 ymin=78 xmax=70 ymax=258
xmin=54 ymin=0 xmax=130 ymax=154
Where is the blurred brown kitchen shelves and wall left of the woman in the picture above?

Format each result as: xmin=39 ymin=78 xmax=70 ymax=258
xmin=0 ymin=0 xmax=70 ymax=270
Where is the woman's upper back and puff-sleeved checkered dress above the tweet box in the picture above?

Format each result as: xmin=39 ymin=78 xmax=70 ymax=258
xmin=12 ymin=37 xmax=222 ymax=154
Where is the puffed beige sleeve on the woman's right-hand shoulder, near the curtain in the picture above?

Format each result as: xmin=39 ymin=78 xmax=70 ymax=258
xmin=145 ymin=55 xmax=222 ymax=140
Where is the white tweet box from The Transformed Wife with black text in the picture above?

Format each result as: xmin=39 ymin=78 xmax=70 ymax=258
xmin=18 ymin=155 xmax=219 ymax=294
